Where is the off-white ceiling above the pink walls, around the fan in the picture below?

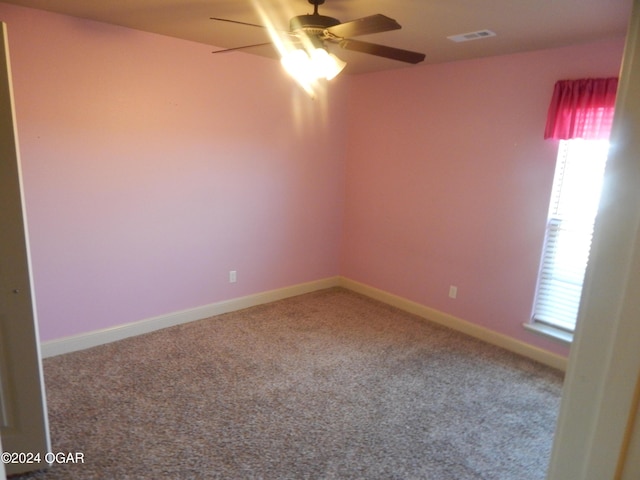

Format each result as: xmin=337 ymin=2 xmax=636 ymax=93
xmin=4 ymin=0 xmax=633 ymax=74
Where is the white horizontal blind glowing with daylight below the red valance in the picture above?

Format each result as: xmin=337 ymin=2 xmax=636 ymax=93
xmin=533 ymin=139 xmax=609 ymax=332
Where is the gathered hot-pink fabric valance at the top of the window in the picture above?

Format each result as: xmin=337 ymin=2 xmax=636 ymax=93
xmin=544 ymin=78 xmax=618 ymax=140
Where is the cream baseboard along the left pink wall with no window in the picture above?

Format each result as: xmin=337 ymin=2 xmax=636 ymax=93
xmin=41 ymin=277 xmax=339 ymax=358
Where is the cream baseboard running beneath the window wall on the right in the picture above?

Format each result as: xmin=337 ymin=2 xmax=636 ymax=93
xmin=339 ymin=277 xmax=567 ymax=371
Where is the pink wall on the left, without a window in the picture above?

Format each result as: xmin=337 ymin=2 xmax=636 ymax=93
xmin=0 ymin=3 xmax=346 ymax=341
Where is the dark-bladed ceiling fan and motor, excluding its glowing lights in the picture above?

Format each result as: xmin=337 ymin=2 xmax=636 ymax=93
xmin=211 ymin=0 xmax=425 ymax=64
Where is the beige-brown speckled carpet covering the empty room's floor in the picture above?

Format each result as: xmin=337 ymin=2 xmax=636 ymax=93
xmin=11 ymin=289 xmax=562 ymax=480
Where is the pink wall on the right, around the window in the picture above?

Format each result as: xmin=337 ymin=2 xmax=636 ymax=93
xmin=341 ymin=38 xmax=624 ymax=354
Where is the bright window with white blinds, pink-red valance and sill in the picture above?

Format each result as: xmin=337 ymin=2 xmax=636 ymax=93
xmin=525 ymin=78 xmax=618 ymax=341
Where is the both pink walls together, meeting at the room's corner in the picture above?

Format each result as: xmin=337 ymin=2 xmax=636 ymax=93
xmin=0 ymin=3 xmax=624 ymax=360
